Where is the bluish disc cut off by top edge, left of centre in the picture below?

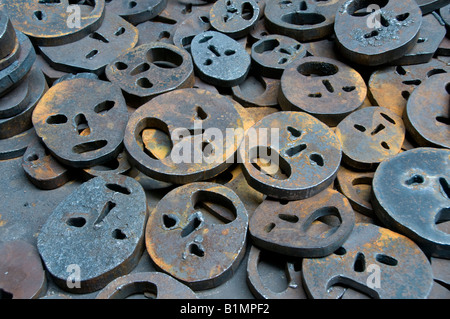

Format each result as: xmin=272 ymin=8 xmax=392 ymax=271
xmin=105 ymin=0 xmax=168 ymax=25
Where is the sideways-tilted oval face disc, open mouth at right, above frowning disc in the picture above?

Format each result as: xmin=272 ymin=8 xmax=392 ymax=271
xmin=249 ymin=189 xmax=355 ymax=258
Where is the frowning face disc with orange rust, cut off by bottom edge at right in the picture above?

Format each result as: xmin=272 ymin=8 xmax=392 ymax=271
xmin=302 ymin=224 xmax=433 ymax=299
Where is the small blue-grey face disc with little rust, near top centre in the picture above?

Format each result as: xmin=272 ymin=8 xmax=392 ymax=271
xmin=191 ymin=31 xmax=251 ymax=87
